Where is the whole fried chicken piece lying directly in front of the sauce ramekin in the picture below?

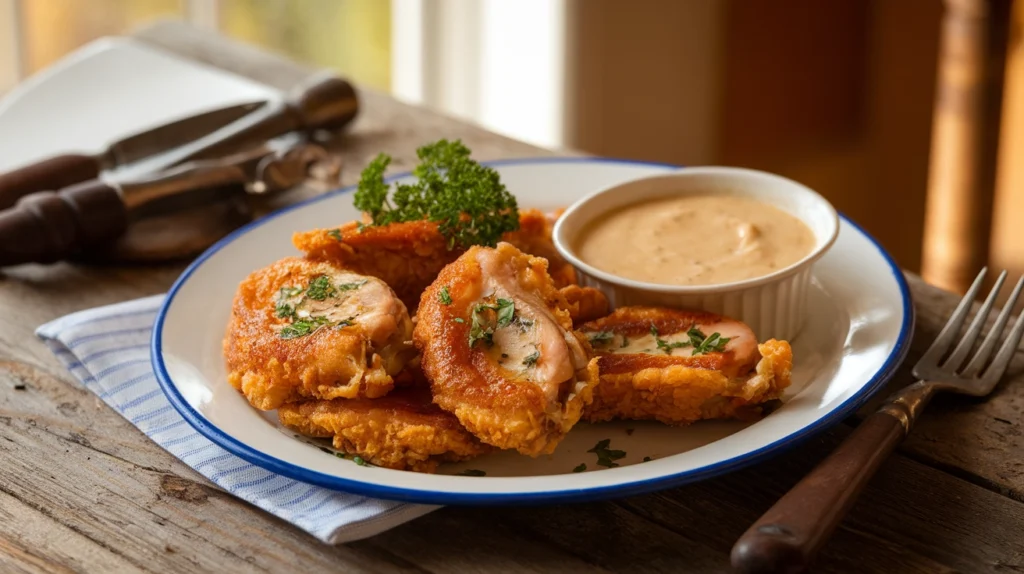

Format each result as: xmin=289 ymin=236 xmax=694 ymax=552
xmin=580 ymin=307 xmax=793 ymax=425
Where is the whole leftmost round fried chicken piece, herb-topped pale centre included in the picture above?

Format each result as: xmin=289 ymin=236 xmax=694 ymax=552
xmin=224 ymin=258 xmax=415 ymax=410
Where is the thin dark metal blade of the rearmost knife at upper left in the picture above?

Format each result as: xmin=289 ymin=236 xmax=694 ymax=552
xmin=103 ymin=100 xmax=267 ymax=169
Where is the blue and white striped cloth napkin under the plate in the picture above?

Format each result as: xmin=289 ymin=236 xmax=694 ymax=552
xmin=36 ymin=296 xmax=437 ymax=543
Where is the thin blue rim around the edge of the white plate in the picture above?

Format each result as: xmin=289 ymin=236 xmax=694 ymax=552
xmin=150 ymin=158 xmax=914 ymax=504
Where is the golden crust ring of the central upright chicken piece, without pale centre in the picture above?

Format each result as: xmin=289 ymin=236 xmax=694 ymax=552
xmin=413 ymin=244 xmax=598 ymax=456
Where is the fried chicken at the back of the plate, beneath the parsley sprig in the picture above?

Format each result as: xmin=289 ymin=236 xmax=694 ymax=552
xmin=292 ymin=210 xmax=575 ymax=310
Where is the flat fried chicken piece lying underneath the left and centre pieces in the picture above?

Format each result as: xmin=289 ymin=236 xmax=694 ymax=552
xmin=278 ymin=389 xmax=493 ymax=473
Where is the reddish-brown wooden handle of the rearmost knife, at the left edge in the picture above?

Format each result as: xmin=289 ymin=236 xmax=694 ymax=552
xmin=0 ymin=153 xmax=101 ymax=210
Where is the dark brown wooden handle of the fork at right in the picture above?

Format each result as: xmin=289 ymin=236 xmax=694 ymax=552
xmin=732 ymin=411 xmax=905 ymax=573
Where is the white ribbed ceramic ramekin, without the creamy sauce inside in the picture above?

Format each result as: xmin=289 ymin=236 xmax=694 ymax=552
xmin=554 ymin=167 xmax=839 ymax=341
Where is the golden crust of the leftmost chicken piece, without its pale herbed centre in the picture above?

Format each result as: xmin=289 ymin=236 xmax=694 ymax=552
xmin=223 ymin=258 xmax=412 ymax=410
